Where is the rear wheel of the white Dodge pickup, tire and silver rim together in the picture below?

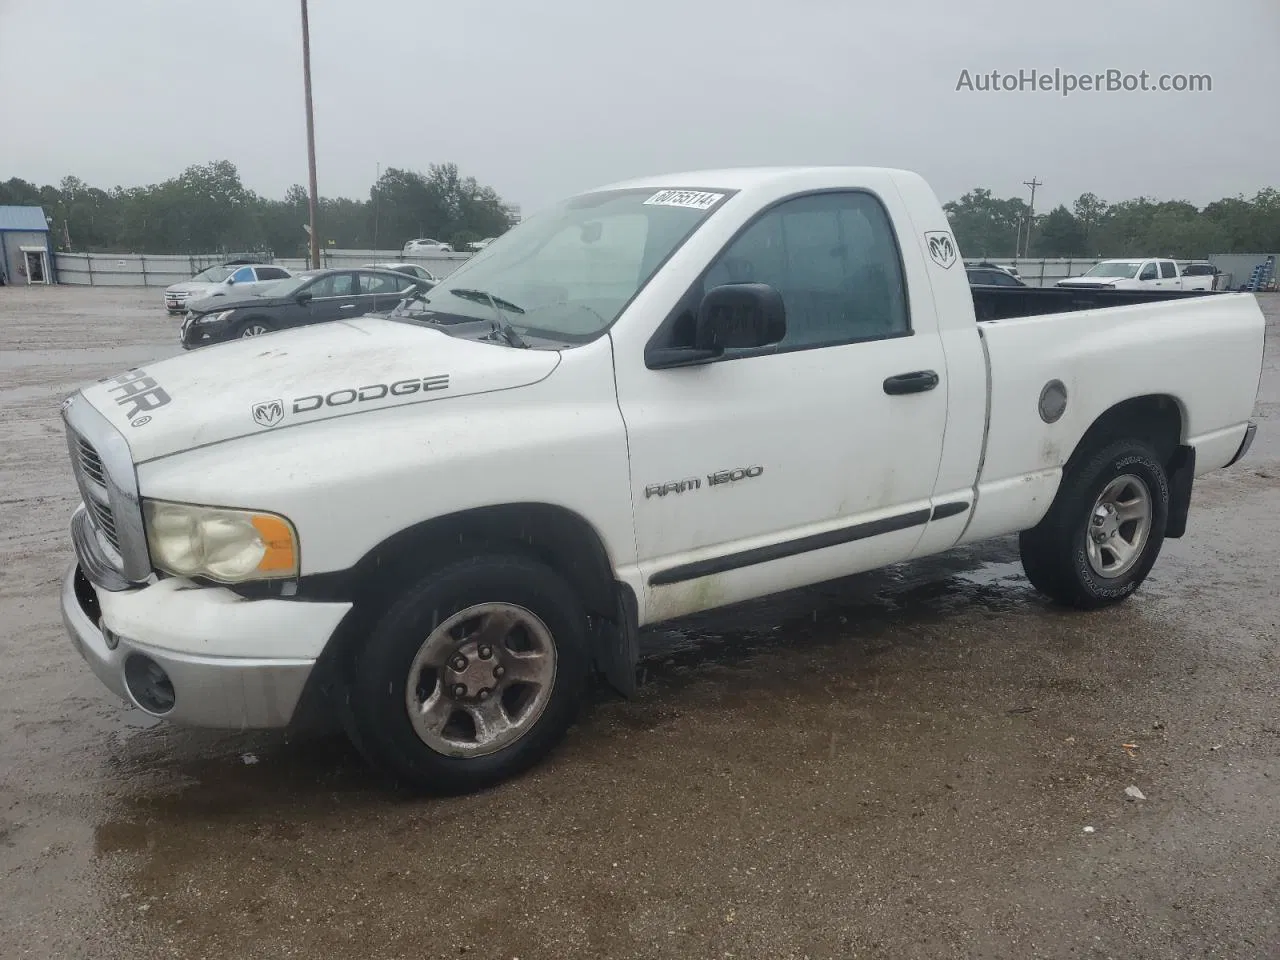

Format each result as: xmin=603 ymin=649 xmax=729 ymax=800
xmin=1019 ymin=440 xmax=1169 ymax=609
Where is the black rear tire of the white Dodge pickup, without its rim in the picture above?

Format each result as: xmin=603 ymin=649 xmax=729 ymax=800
xmin=1018 ymin=440 xmax=1169 ymax=609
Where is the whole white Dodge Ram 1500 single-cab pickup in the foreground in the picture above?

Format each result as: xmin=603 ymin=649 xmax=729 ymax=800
xmin=61 ymin=168 xmax=1263 ymax=791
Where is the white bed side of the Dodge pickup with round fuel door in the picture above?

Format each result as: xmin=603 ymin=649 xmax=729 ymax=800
xmin=955 ymin=289 xmax=1266 ymax=539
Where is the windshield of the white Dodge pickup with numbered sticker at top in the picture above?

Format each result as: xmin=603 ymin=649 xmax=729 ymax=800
xmin=397 ymin=187 xmax=730 ymax=343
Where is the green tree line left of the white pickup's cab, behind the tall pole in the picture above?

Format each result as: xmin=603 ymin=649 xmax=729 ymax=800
xmin=0 ymin=160 xmax=515 ymax=257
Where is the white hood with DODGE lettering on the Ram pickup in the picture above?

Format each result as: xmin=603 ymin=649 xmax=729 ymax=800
xmin=82 ymin=316 xmax=559 ymax=463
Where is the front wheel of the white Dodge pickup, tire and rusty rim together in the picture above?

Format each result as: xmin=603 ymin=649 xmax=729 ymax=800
xmin=347 ymin=556 xmax=589 ymax=794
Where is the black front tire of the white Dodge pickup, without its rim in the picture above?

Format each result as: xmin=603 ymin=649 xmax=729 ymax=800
xmin=344 ymin=554 xmax=590 ymax=794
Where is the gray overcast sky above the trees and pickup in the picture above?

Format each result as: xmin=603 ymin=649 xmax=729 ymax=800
xmin=0 ymin=0 xmax=1280 ymax=212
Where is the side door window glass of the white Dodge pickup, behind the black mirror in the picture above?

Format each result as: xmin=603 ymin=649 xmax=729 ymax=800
xmin=703 ymin=192 xmax=911 ymax=352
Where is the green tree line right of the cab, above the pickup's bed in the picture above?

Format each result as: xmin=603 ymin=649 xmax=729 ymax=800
xmin=943 ymin=187 xmax=1280 ymax=260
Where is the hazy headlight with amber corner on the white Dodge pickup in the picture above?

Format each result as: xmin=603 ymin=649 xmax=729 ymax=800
xmin=142 ymin=500 xmax=298 ymax=584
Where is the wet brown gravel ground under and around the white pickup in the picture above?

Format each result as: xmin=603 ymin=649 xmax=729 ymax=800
xmin=0 ymin=287 xmax=1280 ymax=960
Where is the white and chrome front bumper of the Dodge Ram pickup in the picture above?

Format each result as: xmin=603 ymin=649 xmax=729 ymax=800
xmin=61 ymin=563 xmax=351 ymax=730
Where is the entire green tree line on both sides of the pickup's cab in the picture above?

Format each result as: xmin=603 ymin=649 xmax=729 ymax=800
xmin=0 ymin=160 xmax=1280 ymax=259
